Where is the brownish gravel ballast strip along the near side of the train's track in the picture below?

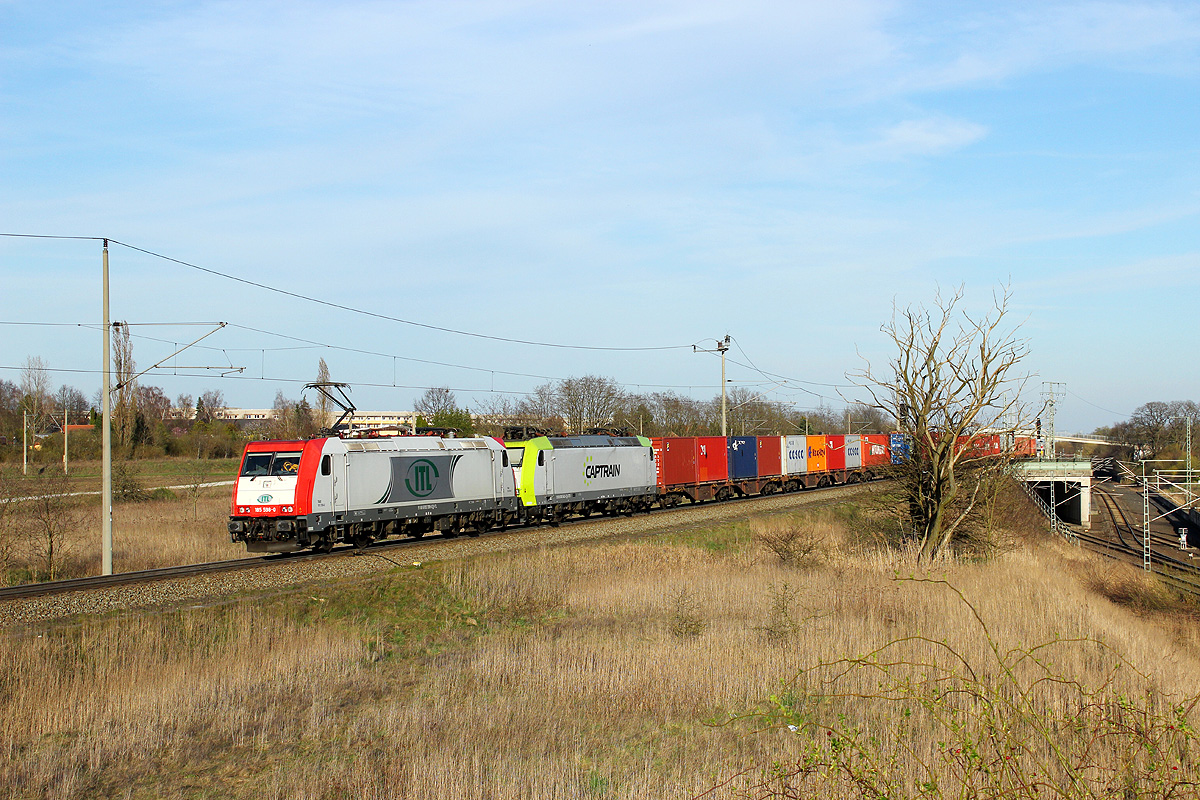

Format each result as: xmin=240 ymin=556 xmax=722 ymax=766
xmin=0 ymin=483 xmax=884 ymax=626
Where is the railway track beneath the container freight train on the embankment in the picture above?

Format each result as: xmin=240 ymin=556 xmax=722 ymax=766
xmin=0 ymin=483 xmax=883 ymax=602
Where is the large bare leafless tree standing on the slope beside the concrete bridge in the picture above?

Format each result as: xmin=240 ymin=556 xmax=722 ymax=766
xmin=853 ymin=287 xmax=1028 ymax=563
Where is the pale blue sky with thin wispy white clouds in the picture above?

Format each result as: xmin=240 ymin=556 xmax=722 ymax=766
xmin=0 ymin=0 xmax=1200 ymax=432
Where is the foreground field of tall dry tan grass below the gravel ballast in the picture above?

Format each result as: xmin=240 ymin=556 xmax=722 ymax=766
xmin=0 ymin=491 xmax=1200 ymax=799
